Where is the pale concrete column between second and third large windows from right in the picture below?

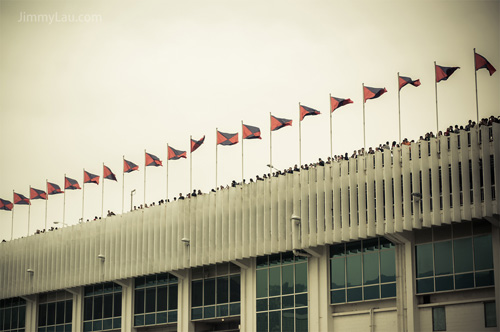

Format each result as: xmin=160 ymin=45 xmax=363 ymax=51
xmin=307 ymin=246 xmax=333 ymax=331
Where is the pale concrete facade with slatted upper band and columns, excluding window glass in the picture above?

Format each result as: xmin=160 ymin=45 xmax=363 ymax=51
xmin=0 ymin=123 xmax=500 ymax=332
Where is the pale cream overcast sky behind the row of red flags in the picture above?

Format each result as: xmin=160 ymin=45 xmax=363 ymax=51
xmin=0 ymin=0 xmax=500 ymax=240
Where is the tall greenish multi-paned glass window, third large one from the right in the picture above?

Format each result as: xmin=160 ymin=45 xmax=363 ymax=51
xmin=256 ymin=252 xmax=307 ymax=332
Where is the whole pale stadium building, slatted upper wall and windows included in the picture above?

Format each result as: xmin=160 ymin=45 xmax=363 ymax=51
xmin=0 ymin=123 xmax=500 ymax=332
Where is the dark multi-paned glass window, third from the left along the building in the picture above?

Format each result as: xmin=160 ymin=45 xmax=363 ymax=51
xmin=84 ymin=282 xmax=122 ymax=331
